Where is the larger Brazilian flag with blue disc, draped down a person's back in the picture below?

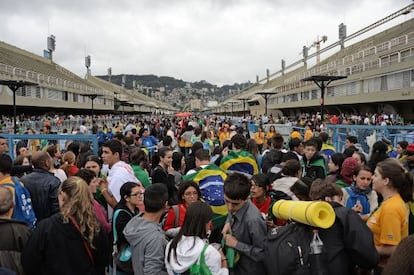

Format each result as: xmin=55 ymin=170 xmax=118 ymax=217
xmin=182 ymin=164 xmax=228 ymax=228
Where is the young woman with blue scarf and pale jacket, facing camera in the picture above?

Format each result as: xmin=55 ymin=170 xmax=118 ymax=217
xmin=342 ymin=165 xmax=378 ymax=221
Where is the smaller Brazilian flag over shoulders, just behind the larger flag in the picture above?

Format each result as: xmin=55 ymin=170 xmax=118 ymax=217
xmin=220 ymin=150 xmax=259 ymax=176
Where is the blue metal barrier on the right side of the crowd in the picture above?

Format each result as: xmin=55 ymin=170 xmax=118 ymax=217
xmin=327 ymin=124 xmax=414 ymax=153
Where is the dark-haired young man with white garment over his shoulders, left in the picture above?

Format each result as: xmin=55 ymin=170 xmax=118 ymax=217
xmin=101 ymin=139 xmax=139 ymax=202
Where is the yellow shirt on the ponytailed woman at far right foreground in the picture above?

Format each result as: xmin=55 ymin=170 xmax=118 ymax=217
xmin=367 ymin=194 xmax=409 ymax=246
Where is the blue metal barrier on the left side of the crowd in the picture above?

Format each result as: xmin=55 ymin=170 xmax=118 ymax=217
xmin=1 ymin=134 xmax=99 ymax=159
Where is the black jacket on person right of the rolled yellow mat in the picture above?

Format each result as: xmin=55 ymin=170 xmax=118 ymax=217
xmin=319 ymin=202 xmax=379 ymax=275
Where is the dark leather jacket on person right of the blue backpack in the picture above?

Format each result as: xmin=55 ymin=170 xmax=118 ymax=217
xmin=21 ymin=169 xmax=60 ymax=222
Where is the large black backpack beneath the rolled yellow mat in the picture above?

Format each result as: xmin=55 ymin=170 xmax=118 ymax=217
xmin=264 ymin=222 xmax=313 ymax=275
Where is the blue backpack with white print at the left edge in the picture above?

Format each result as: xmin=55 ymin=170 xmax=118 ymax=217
xmin=2 ymin=177 xmax=36 ymax=228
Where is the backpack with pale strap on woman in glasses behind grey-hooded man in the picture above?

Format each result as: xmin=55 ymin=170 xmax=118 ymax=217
xmin=112 ymin=209 xmax=134 ymax=274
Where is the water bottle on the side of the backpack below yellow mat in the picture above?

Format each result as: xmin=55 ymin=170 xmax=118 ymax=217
xmin=309 ymin=229 xmax=328 ymax=275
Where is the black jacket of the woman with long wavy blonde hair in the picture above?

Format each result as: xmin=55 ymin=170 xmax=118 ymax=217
xmin=22 ymin=213 xmax=110 ymax=275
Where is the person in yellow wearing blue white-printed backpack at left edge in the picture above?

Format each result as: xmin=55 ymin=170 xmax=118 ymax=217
xmin=0 ymin=154 xmax=36 ymax=228
